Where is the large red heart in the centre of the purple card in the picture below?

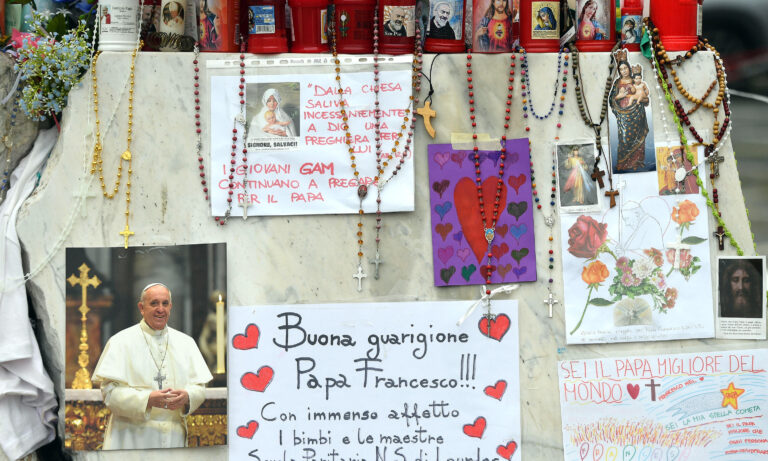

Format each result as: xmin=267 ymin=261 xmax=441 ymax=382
xmin=453 ymin=176 xmax=507 ymax=264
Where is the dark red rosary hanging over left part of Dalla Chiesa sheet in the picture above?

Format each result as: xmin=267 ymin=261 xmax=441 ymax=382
xmin=192 ymin=39 xmax=251 ymax=226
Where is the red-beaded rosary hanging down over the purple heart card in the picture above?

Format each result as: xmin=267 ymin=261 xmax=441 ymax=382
xmin=467 ymin=49 xmax=515 ymax=294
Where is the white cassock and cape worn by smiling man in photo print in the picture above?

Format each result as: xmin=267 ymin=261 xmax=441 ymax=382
xmin=92 ymin=320 xmax=213 ymax=450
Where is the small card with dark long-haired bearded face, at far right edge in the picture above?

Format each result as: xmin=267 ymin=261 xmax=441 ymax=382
xmin=715 ymin=256 xmax=766 ymax=339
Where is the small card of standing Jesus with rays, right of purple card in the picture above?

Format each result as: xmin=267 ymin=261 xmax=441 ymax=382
xmin=555 ymin=141 xmax=601 ymax=213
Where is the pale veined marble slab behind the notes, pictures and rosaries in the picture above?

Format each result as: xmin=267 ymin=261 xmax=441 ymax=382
xmin=13 ymin=52 xmax=759 ymax=461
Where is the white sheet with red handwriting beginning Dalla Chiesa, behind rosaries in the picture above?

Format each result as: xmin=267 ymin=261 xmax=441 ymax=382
xmin=210 ymin=68 xmax=414 ymax=216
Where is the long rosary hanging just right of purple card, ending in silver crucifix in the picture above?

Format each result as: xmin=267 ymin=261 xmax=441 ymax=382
xmin=521 ymin=48 xmax=569 ymax=318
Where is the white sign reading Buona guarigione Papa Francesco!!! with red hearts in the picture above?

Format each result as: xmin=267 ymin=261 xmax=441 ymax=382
xmin=229 ymin=301 xmax=521 ymax=461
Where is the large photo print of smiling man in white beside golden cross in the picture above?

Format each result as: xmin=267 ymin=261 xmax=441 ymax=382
xmin=64 ymin=243 xmax=227 ymax=451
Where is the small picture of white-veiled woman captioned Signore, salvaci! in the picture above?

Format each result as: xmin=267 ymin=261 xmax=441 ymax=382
xmin=245 ymin=82 xmax=301 ymax=151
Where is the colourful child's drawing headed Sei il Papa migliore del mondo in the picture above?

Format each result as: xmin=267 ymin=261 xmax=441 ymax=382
xmin=558 ymin=350 xmax=768 ymax=461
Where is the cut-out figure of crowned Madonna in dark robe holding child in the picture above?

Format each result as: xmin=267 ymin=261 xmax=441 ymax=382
xmin=608 ymin=49 xmax=656 ymax=173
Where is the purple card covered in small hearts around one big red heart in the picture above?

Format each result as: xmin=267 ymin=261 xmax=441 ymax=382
xmin=428 ymin=138 xmax=536 ymax=286
